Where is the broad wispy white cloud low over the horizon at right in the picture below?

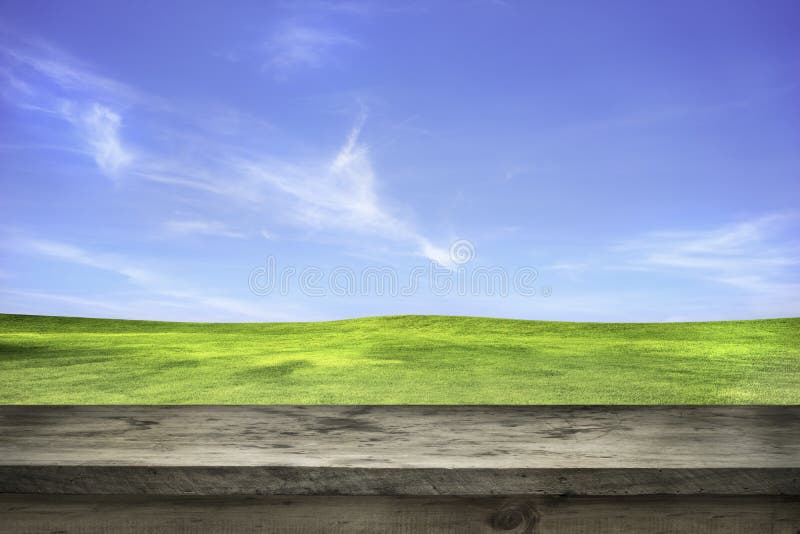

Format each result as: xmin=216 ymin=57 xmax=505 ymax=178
xmin=543 ymin=213 xmax=800 ymax=321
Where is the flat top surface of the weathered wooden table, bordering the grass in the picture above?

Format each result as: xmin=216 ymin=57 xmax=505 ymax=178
xmin=0 ymin=406 xmax=800 ymax=469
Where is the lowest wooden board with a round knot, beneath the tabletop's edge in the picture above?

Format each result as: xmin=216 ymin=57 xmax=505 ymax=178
xmin=0 ymin=495 xmax=800 ymax=534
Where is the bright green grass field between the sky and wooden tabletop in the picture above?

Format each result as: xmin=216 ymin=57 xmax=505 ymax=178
xmin=0 ymin=315 xmax=800 ymax=404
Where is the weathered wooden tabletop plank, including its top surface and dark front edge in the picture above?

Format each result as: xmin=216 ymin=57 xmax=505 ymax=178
xmin=0 ymin=406 xmax=800 ymax=500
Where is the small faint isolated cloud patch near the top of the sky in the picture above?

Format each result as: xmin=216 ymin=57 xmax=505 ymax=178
xmin=265 ymin=22 xmax=360 ymax=78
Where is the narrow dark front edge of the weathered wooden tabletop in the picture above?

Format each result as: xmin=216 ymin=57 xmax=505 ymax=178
xmin=0 ymin=466 xmax=800 ymax=495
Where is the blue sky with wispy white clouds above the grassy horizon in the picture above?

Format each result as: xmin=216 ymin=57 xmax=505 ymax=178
xmin=0 ymin=0 xmax=800 ymax=321
